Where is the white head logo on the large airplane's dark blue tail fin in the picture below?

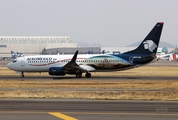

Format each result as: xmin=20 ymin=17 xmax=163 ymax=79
xmin=143 ymin=40 xmax=157 ymax=52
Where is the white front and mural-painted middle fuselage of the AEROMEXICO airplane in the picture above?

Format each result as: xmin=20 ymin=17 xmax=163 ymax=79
xmin=7 ymin=54 xmax=130 ymax=72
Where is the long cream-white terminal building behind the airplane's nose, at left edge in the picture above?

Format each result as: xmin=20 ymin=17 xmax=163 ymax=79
xmin=0 ymin=36 xmax=77 ymax=58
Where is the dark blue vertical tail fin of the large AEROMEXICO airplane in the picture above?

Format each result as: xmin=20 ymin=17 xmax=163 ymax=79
xmin=123 ymin=22 xmax=164 ymax=54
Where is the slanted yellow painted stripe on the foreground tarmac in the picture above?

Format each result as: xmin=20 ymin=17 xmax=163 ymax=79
xmin=48 ymin=112 xmax=77 ymax=120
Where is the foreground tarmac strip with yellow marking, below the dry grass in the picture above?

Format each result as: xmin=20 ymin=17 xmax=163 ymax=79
xmin=0 ymin=99 xmax=178 ymax=120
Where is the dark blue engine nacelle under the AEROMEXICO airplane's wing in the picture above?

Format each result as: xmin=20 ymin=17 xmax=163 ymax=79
xmin=48 ymin=67 xmax=65 ymax=75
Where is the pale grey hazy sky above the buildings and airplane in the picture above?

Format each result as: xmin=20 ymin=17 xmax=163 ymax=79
xmin=0 ymin=0 xmax=178 ymax=47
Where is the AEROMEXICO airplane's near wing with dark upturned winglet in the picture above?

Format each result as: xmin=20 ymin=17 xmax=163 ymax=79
xmin=63 ymin=51 xmax=95 ymax=73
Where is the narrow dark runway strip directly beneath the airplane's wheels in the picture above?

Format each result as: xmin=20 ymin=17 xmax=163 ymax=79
xmin=0 ymin=75 xmax=178 ymax=80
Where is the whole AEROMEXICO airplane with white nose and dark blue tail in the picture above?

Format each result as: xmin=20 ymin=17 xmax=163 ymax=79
xmin=7 ymin=22 xmax=164 ymax=78
